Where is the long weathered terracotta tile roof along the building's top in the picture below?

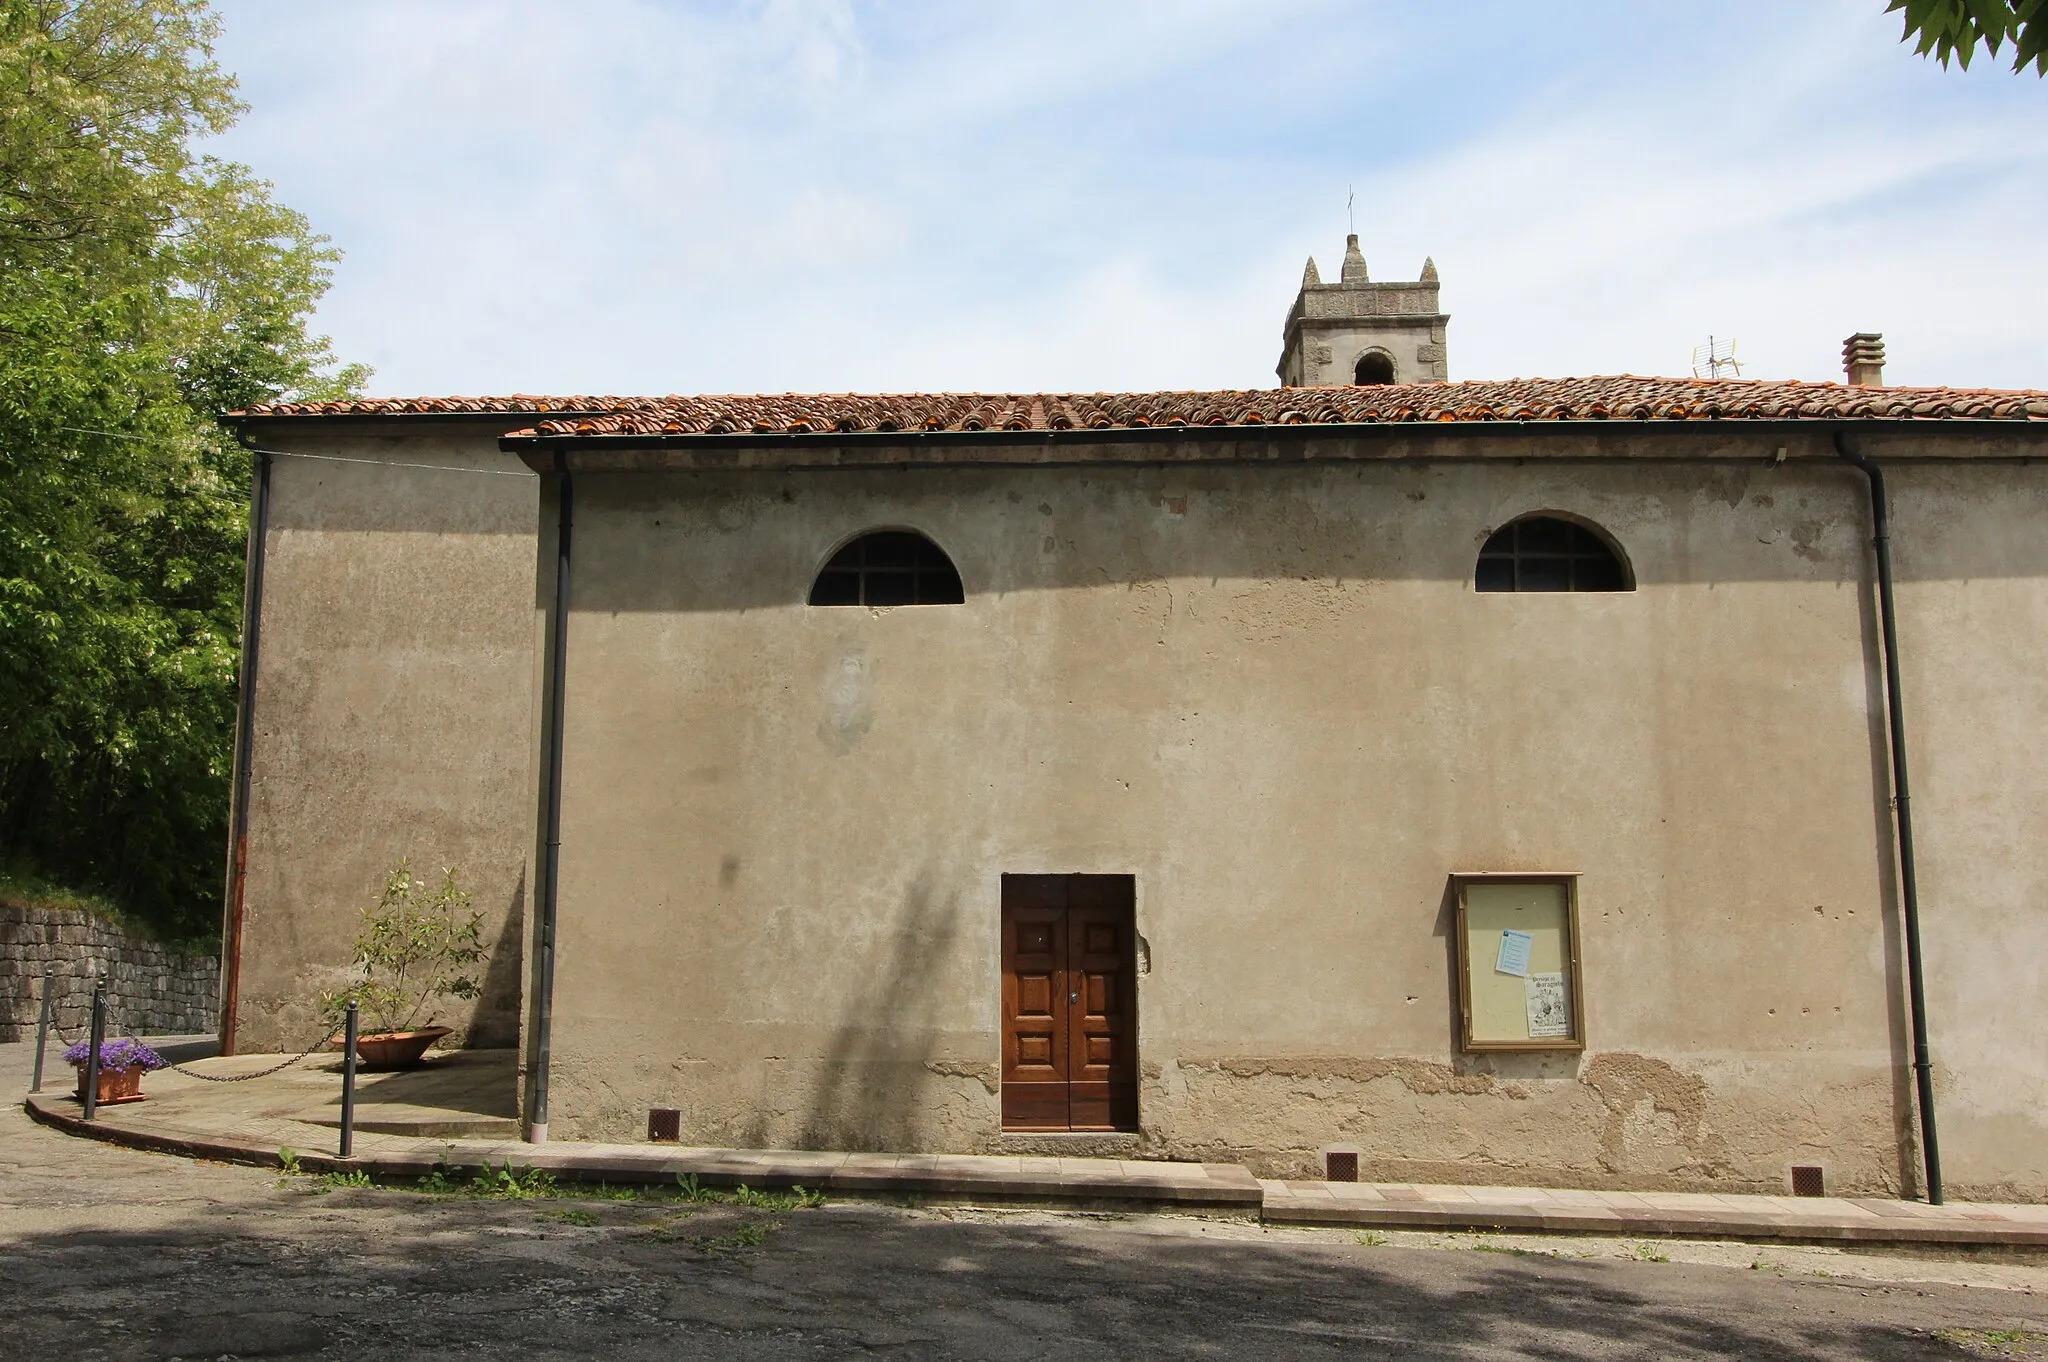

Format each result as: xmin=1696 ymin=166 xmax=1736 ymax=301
xmin=244 ymin=375 xmax=2048 ymax=438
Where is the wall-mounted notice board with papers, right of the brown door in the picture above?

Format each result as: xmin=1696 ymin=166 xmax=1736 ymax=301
xmin=1452 ymin=875 xmax=1585 ymax=1051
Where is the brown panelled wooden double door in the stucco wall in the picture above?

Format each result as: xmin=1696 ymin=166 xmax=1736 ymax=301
xmin=1004 ymin=875 xmax=1139 ymax=1131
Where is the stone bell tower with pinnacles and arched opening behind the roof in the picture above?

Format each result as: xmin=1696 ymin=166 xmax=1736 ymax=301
xmin=1278 ymin=231 xmax=1450 ymax=387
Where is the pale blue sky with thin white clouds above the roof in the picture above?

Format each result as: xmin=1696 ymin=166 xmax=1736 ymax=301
xmin=209 ymin=0 xmax=2048 ymax=393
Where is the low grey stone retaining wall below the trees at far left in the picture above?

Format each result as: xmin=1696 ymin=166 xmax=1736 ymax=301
xmin=0 ymin=903 xmax=221 ymax=1042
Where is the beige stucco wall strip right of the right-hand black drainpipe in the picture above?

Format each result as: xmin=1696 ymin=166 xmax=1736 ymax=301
xmin=1888 ymin=465 xmax=2048 ymax=1200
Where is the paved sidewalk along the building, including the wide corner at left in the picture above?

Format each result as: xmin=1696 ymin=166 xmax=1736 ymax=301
xmin=27 ymin=1051 xmax=2048 ymax=1249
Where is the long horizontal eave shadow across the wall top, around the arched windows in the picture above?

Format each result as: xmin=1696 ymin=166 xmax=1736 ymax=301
xmin=548 ymin=463 xmax=2048 ymax=612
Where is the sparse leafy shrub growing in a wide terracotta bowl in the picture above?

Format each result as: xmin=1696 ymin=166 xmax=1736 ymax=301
xmin=319 ymin=860 xmax=485 ymax=1069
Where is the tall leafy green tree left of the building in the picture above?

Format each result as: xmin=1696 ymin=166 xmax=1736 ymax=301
xmin=0 ymin=0 xmax=367 ymax=940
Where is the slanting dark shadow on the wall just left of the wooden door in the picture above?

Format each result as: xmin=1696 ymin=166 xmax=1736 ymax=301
xmin=786 ymin=872 xmax=961 ymax=1151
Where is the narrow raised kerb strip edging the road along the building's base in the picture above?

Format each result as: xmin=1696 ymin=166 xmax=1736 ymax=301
xmin=25 ymin=1094 xmax=2048 ymax=1249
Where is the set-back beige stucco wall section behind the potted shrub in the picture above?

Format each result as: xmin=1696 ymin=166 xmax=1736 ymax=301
xmin=238 ymin=418 xmax=539 ymax=1053
